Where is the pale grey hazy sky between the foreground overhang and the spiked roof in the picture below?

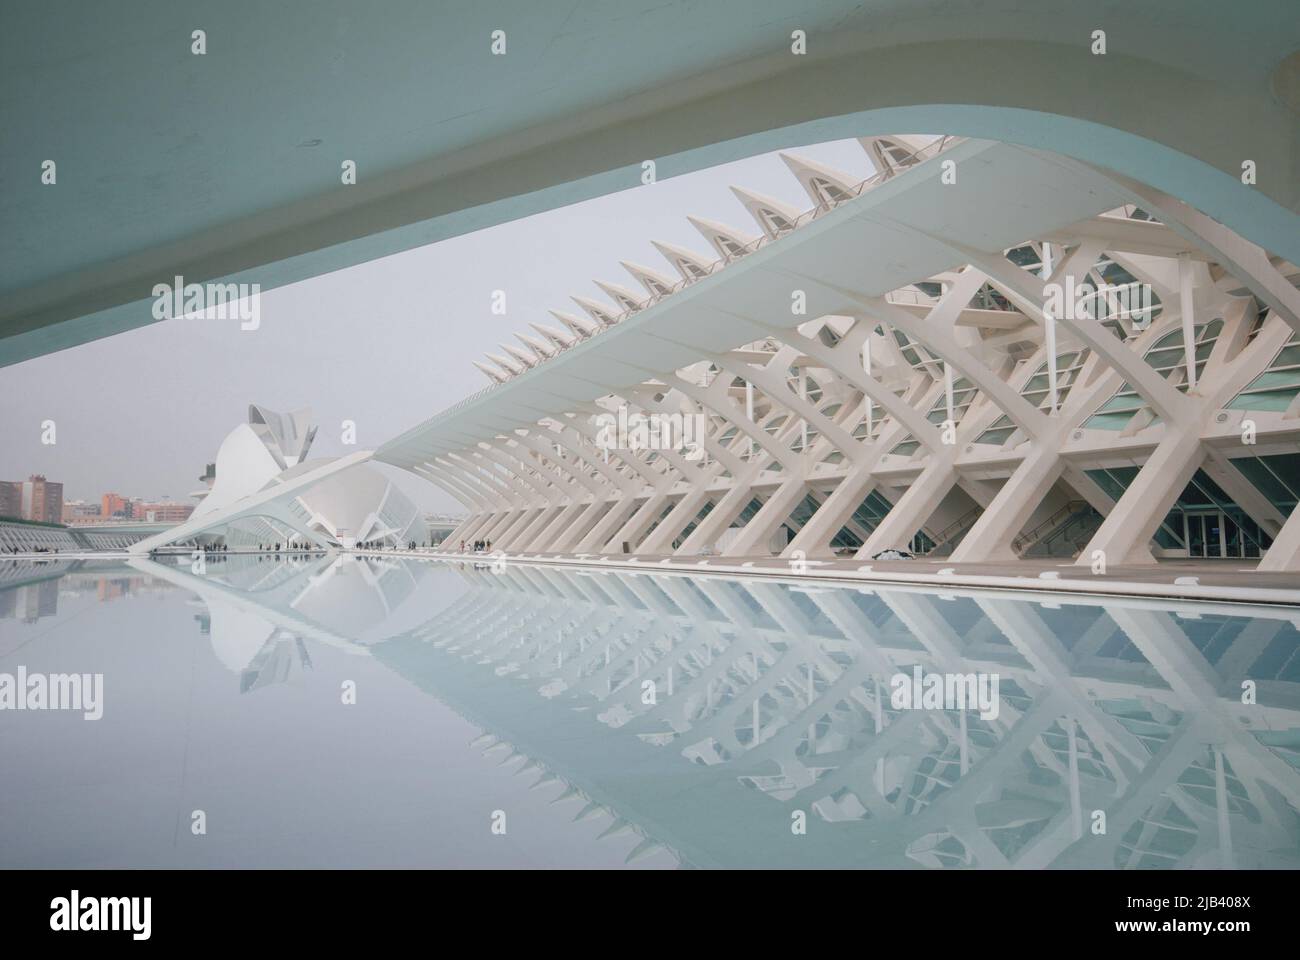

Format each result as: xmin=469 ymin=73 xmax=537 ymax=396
xmin=0 ymin=134 xmax=874 ymax=514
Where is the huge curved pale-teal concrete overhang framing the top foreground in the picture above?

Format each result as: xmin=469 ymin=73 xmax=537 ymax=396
xmin=0 ymin=0 xmax=1300 ymax=364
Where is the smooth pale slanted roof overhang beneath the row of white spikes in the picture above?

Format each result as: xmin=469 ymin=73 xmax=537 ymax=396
xmin=374 ymin=140 xmax=1126 ymax=470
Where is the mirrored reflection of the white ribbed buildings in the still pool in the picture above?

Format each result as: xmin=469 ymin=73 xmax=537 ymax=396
xmin=116 ymin=555 xmax=1300 ymax=869
